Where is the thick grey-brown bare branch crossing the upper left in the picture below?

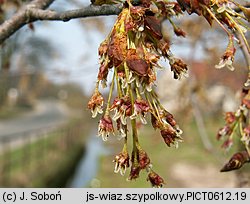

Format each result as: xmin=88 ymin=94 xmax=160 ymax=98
xmin=0 ymin=0 xmax=121 ymax=45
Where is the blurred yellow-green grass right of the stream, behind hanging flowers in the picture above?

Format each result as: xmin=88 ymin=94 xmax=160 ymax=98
xmin=96 ymin=116 xmax=240 ymax=188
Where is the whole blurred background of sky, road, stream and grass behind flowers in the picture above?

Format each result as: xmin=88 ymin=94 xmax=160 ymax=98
xmin=0 ymin=0 xmax=249 ymax=187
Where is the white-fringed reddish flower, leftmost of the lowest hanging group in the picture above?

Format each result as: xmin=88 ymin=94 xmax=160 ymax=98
xmin=113 ymin=151 xmax=129 ymax=176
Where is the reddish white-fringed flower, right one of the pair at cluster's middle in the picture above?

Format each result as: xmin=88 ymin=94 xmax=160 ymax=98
xmin=130 ymin=99 xmax=150 ymax=124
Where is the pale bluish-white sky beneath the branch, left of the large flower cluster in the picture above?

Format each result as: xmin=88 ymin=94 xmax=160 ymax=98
xmin=27 ymin=0 xmax=115 ymax=92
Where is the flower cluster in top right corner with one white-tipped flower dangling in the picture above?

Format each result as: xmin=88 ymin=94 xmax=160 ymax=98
xmin=177 ymin=0 xmax=250 ymax=83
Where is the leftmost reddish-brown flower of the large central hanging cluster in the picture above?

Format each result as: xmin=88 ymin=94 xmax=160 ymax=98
xmin=88 ymin=90 xmax=104 ymax=118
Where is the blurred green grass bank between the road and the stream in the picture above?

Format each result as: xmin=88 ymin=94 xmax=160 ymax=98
xmin=0 ymin=118 xmax=88 ymax=187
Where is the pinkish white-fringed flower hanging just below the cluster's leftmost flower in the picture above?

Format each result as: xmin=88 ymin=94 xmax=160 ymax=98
xmin=98 ymin=115 xmax=114 ymax=141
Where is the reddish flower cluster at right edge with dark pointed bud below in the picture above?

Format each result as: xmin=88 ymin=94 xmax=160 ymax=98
xmin=217 ymin=89 xmax=250 ymax=171
